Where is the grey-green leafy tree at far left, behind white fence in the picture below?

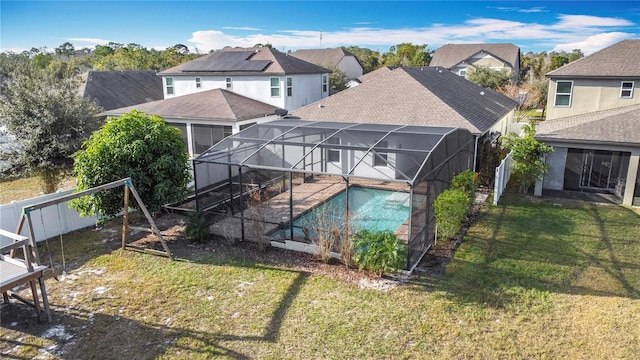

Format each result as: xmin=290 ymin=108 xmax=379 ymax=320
xmin=0 ymin=63 xmax=100 ymax=193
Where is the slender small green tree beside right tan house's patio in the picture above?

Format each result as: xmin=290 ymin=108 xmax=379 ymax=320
xmin=500 ymin=122 xmax=553 ymax=194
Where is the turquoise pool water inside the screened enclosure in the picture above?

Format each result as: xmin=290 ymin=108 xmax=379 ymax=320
xmin=293 ymin=187 xmax=410 ymax=235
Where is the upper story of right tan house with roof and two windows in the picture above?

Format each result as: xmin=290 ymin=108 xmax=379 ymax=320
xmin=546 ymin=39 xmax=640 ymax=119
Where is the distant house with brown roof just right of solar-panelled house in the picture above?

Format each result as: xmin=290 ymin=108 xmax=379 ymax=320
xmin=291 ymin=48 xmax=363 ymax=81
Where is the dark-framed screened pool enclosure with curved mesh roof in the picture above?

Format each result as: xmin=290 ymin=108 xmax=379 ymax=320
xmin=193 ymin=119 xmax=475 ymax=270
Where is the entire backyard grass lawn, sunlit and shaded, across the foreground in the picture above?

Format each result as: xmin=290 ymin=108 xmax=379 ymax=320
xmin=0 ymin=194 xmax=640 ymax=359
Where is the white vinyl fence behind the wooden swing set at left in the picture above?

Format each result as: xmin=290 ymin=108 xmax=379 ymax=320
xmin=0 ymin=189 xmax=96 ymax=245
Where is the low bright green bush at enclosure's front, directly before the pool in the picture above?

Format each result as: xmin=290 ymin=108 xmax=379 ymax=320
xmin=351 ymin=230 xmax=407 ymax=275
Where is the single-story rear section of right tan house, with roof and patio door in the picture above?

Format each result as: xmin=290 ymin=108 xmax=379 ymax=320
xmin=535 ymin=104 xmax=640 ymax=206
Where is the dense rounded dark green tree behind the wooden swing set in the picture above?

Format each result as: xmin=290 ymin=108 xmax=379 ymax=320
xmin=72 ymin=110 xmax=191 ymax=216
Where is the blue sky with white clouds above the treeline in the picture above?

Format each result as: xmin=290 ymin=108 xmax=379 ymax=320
xmin=0 ymin=0 xmax=640 ymax=54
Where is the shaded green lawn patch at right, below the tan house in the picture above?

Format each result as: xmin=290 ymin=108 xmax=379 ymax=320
xmin=412 ymin=196 xmax=640 ymax=308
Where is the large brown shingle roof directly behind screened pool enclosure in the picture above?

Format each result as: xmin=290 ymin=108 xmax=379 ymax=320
xmin=292 ymin=67 xmax=516 ymax=134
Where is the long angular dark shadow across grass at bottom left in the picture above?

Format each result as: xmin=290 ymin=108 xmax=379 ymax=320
xmin=0 ymin=265 xmax=309 ymax=359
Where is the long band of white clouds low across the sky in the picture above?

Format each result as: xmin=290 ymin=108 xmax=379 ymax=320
xmin=188 ymin=13 xmax=634 ymax=54
